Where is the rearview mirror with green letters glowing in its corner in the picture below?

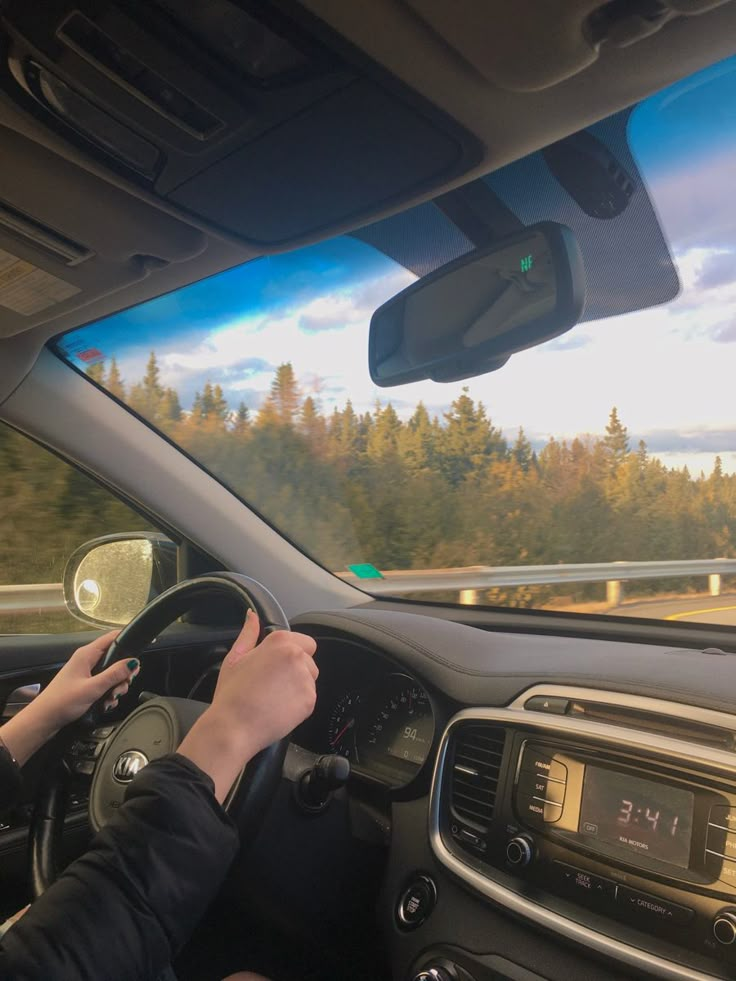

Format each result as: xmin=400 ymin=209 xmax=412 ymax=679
xmin=368 ymin=222 xmax=585 ymax=387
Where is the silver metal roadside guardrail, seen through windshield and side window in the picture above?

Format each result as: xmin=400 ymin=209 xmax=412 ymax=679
xmin=0 ymin=559 xmax=736 ymax=614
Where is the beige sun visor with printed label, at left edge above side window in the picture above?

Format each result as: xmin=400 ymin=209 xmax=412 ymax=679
xmin=0 ymin=127 xmax=206 ymax=337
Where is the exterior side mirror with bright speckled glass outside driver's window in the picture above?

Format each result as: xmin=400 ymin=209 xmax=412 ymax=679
xmin=64 ymin=532 xmax=177 ymax=627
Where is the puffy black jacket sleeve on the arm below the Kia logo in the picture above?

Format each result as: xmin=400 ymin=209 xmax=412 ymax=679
xmin=0 ymin=755 xmax=238 ymax=981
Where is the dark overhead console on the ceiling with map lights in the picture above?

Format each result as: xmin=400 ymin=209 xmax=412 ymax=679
xmin=0 ymin=0 xmax=480 ymax=246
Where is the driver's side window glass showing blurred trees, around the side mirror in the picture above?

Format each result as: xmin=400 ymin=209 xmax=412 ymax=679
xmin=0 ymin=423 xmax=157 ymax=636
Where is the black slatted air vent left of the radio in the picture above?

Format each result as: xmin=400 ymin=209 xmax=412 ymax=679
xmin=450 ymin=723 xmax=506 ymax=831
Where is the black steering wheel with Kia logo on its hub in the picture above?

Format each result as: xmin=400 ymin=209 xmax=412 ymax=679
xmin=29 ymin=572 xmax=290 ymax=898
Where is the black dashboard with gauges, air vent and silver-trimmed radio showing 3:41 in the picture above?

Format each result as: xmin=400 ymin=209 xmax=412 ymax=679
xmin=269 ymin=610 xmax=736 ymax=981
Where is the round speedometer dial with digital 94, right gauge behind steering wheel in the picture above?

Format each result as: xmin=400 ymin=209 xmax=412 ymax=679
xmin=358 ymin=674 xmax=434 ymax=783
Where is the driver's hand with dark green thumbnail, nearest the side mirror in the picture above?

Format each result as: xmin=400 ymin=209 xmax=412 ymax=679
xmin=33 ymin=630 xmax=140 ymax=730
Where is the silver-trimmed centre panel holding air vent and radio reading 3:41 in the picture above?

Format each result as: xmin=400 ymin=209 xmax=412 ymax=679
xmin=430 ymin=686 xmax=736 ymax=979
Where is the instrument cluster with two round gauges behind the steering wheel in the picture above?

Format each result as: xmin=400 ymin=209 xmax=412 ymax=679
xmin=292 ymin=639 xmax=436 ymax=788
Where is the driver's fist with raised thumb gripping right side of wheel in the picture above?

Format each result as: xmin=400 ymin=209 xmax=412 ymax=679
xmin=179 ymin=611 xmax=319 ymax=801
